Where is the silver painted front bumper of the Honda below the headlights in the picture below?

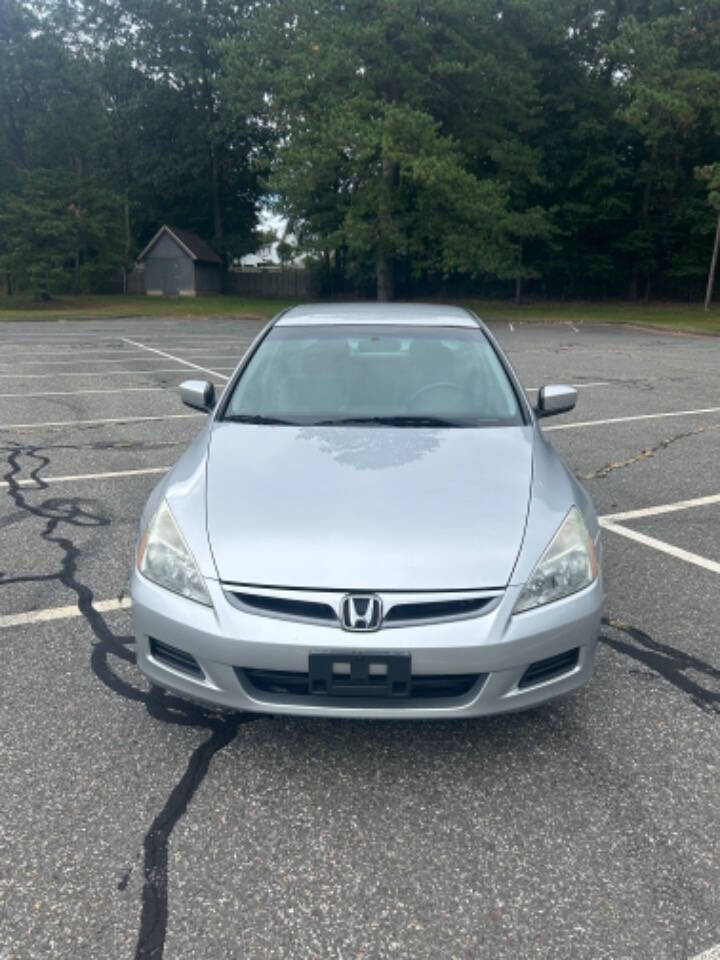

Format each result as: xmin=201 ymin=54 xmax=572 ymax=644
xmin=132 ymin=571 xmax=603 ymax=719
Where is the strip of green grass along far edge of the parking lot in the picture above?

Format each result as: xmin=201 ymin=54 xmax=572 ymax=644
xmin=0 ymin=295 xmax=720 ymax=334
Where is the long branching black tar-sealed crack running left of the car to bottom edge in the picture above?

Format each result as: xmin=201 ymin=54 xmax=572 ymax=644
xmin=0 ymin=444 xmax=264 ymax=960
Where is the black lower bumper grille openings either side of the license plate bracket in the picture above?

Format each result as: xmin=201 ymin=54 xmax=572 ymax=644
xmin=240 ymin=667 xmax=487 ymax=705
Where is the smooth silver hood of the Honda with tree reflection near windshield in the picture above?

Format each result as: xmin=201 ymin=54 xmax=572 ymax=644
xmin=207 ymin=422 xmax=533 ymax=590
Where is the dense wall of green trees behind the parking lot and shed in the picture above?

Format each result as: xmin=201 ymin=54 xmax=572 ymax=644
xmin=0 ymin=0 xmax=720 ymax=298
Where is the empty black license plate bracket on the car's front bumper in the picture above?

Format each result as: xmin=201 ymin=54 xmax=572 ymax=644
xmin=308 ymin=651 xmax=411 ymax=698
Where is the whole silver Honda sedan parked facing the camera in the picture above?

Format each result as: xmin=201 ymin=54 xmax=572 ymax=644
xmin=132 ymin=304 xmax=603 ymax=718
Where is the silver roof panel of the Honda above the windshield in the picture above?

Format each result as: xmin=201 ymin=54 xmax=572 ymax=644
xmin=275 ymin=303 xmax=479 ymax=328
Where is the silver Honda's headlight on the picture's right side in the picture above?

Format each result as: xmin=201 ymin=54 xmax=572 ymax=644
xmin=513 ymin=507 xmax=598 ymax=613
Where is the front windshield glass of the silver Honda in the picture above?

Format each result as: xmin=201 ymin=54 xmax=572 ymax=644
xmin=222 ymin=325 xmax=523 ymax=427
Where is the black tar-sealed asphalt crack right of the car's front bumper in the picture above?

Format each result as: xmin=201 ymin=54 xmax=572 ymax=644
xmin=600 ymin=617 xmax=720 ymax=715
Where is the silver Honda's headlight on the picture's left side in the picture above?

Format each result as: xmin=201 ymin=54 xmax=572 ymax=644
xmin=137 ymin=500 xmax=212 ymax=607
